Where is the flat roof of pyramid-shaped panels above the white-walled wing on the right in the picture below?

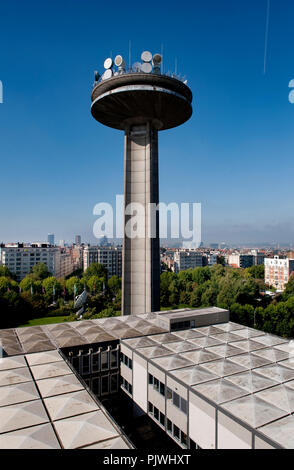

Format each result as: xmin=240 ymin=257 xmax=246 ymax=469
xmin=121 ymin=322 xmax=294 ymax=448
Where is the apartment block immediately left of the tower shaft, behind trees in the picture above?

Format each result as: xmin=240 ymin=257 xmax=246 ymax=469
xmin=83 ymin=245 xmax=122 ymax=277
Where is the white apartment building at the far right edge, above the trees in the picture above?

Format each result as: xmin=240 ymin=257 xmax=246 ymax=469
xmin=264 ymin=255 xmax=294 ymax=292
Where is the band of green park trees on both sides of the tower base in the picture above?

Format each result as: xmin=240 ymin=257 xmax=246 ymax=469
xmin=0 ymin=263 xmax=294 ymax=338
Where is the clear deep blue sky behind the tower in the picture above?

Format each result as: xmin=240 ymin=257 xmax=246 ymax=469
xmin=0 ymin=0 xmax=294 ymax=243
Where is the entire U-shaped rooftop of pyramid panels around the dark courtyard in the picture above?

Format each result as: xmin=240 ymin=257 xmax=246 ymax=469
xmin=0 ymin=309 xmax=294 ymax=449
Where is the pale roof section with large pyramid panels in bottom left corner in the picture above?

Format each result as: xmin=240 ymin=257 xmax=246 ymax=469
xmin=0 ymin=350 xmax=132 ymax=449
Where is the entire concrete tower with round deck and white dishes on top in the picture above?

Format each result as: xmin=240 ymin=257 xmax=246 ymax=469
xmin=91 ymin=51 xmax=192 ymax=315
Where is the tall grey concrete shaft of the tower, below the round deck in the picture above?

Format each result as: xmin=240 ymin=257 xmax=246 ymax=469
xmin=122 ymin=123 xmax=160 ymax=314
